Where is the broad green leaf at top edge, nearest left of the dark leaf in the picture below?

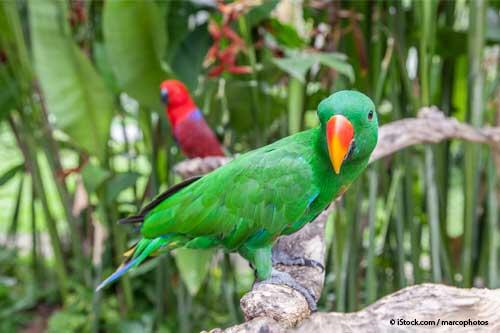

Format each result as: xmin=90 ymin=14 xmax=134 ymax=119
xmin=103 ymin=1 xmax=167 ymax=109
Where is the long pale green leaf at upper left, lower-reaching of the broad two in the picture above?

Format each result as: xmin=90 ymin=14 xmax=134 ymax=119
xmin=29 ymin=0 xmax=113 ymax=160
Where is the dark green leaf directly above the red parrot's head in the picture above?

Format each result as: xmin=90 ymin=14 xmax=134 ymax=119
xmin=172 ymin=24 xmax=212 ymax=91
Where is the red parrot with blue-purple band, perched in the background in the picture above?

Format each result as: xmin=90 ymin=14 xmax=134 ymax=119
xmin=160 ymin=80 xmax=224 ymax=158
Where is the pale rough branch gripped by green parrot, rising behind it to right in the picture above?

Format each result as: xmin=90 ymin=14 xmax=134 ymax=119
xmin=175 ymin=107 xmax=500 ymax=332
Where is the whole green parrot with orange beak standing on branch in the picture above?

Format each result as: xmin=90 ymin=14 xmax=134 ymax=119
xmin=97 ymin=90 xmax=378 ymax=310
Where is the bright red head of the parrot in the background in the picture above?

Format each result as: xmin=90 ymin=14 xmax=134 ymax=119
xmin=160 ymin=80 xmax=196 ymax=125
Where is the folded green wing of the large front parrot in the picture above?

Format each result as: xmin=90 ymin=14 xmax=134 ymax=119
xmin=141 ymin=130 xmax=319 ymax=249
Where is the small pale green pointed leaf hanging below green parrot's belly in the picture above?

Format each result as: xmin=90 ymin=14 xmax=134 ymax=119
xmin=174 ymin=249 xmax=215 ymax=295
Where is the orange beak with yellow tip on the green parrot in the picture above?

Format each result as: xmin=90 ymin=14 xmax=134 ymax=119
xmin=326 ymin=115 xmax=354 ymax=174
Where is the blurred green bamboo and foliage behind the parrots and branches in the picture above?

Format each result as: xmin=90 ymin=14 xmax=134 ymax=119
xmin=0 ymin=0 xmax=500 ymax=332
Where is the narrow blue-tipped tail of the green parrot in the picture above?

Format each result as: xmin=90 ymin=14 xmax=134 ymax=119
xmin=95 ymin=233 xmax=185 ymax=292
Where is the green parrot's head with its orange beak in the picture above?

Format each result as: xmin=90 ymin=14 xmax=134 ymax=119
xmin=318 ymin=90 xmax=378 ymax=174
